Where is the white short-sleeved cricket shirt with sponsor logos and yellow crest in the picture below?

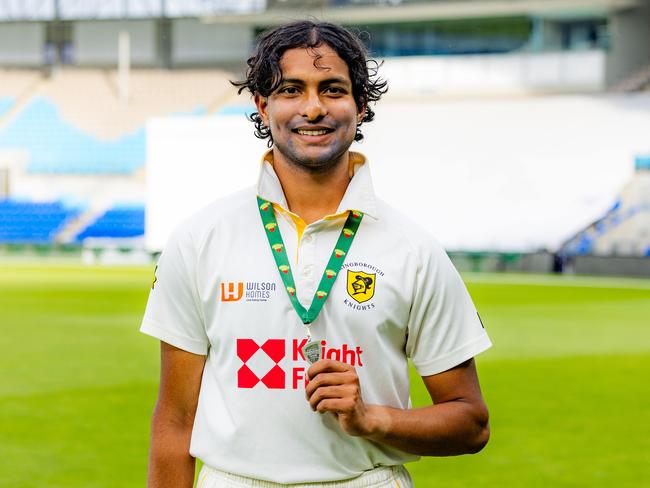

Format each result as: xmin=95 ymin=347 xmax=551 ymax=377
xmin=141 ymin=153 xmax=490 ymax=483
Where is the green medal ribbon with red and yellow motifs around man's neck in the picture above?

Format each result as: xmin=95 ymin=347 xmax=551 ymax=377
xmin=257 ymin=197 xmax=363 ymax=325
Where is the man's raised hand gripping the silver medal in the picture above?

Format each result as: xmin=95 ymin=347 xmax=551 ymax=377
xmin=306 ymin=359 xmax=375 ymax=436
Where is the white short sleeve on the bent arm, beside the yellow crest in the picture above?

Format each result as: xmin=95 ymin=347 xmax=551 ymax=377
xmin=406 ymin=241 xmax=492 ymax=376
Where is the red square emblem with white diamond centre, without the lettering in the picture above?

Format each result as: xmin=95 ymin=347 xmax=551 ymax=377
xmin=237 ymin=339 xmax=285 ymax=388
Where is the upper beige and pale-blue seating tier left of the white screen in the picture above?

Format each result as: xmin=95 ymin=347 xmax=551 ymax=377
xmin=0 ymin=70 xmax=234 ymax=175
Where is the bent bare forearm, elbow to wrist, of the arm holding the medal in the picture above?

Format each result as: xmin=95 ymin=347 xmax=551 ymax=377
xmin=364 ymin=400 xmax=490 ymax=456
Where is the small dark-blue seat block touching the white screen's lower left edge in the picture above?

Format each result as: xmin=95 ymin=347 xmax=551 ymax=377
xmin=76 ymin=205 xmax=144 ymax=242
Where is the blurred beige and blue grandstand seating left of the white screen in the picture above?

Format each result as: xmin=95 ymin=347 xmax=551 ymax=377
xmin=0 ymin=68 xmax=235 ymax=248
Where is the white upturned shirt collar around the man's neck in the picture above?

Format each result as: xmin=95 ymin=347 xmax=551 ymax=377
xmin=257 ymin=149 xmax=378 ymax=219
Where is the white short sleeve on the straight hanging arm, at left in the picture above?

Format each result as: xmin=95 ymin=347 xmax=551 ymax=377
xmin=140 ymin=227 xmax=209 ymax=355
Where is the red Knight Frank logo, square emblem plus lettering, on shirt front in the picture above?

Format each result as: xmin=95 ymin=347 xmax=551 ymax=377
xmin=237 ymin=339 xmax=363 ymax=390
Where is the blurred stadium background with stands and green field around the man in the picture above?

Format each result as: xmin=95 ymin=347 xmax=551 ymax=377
xmin=0 ymin=0 xmax=650 ymax=487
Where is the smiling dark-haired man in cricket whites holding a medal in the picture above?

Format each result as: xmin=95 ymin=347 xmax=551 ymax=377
xmin=142 ymin=22 xmax=490 ymax=488
